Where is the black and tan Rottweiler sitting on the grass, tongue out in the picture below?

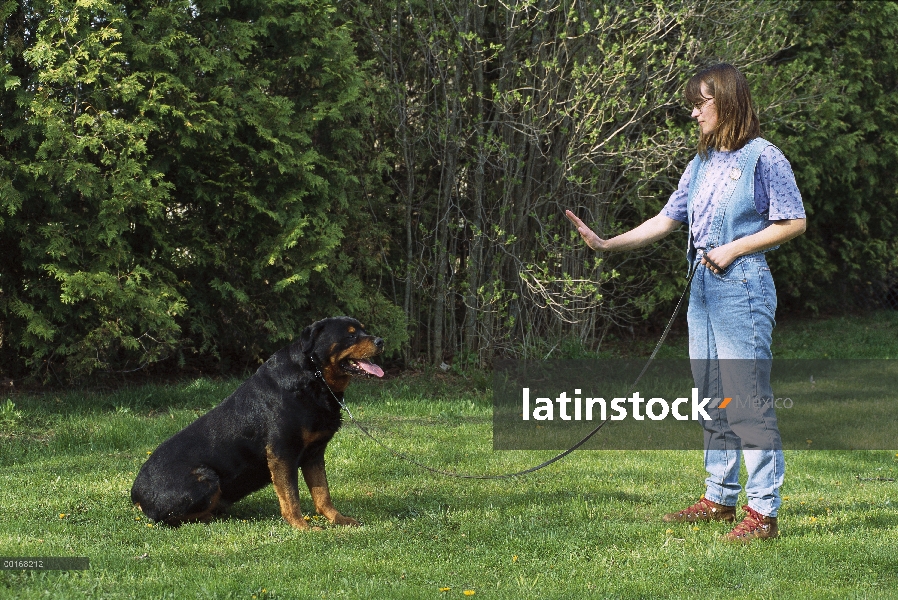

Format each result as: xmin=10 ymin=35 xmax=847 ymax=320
xmin=131 ymin=317 xmax=384 ymax=529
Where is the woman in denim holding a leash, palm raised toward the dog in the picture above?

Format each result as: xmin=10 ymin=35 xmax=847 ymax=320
xmin=566 ymin=64 xmax=805 ymax=542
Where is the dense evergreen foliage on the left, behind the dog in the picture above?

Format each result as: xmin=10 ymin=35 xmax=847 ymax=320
xmin=0 ymin=0 xmax=401 ymax=377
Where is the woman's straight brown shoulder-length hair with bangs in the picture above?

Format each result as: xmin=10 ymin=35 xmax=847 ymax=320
xmin=686 ymin=63 xmax=761 ymax=159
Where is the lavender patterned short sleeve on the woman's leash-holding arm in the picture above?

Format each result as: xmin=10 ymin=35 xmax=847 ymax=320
xmin=755 ymin=146 xmax=805 ymax=221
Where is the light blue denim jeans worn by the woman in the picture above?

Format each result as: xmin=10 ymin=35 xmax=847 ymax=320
xmin=687 ymin=253 xmax=785 ymax=517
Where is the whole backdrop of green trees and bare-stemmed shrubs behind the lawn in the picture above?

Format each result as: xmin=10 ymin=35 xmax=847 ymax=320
xmin=0 ymin=0 xmax=898 ymax=381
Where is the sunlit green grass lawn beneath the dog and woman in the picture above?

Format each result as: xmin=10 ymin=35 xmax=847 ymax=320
xmin=0 ymin=313 xmax=898 ymax=600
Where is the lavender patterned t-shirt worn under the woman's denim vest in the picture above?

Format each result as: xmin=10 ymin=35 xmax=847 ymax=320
xmin=661 ymin=146 xmax=805 ymax=248
